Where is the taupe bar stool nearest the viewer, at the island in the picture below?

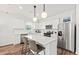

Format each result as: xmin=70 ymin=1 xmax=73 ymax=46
xmin=28 ymin=40 xmax=45 ymax=55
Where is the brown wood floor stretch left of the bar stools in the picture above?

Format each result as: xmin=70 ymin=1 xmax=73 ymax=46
xmin=0 ymin=44 xmax=25 ymax=55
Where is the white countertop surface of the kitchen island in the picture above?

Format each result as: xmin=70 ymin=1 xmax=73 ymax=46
xmin=25 ymin=33 xmax=57 ymax=45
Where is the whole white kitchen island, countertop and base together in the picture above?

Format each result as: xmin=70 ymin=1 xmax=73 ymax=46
xmin=25 ymin=34 xmax=57 ymax=55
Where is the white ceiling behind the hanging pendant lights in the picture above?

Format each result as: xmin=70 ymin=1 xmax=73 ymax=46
xmin=0 ymin=4 xmax=74 ymax=21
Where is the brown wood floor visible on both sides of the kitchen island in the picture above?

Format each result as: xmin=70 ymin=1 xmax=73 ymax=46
xmin=0 ymin=44 xmax=75 ymax=55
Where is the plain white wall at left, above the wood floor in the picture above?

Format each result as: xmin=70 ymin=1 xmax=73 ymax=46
xmin=0 ymin=14 xmax=24 ymax=46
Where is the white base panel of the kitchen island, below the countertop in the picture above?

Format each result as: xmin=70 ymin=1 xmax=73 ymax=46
xmin=39 ymin=40 xmax=57 ymax=55
